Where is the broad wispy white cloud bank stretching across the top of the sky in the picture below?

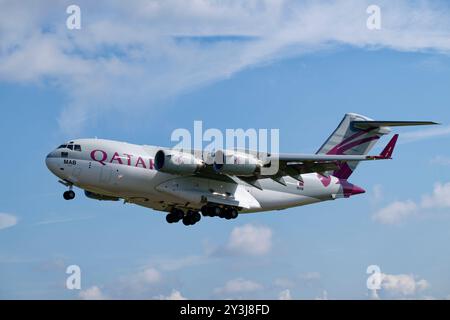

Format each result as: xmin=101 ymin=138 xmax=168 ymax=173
xmin=0 ymin=0 xmax=450 ymax=132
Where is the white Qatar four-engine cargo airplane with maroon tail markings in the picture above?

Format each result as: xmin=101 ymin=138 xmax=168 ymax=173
xmin=45 ymin=113 xmax=437 ymax=226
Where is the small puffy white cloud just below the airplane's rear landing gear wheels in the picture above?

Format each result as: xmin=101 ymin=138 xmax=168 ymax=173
xmin=227 ymin=224 xmax=272 ymax=256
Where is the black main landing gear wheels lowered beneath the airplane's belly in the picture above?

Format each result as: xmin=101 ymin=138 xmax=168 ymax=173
xmin=166 ymin=205 xmax=239 ymax=226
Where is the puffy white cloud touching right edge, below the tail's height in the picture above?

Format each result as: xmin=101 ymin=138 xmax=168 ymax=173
xmin=372 ymin=182 xmax=450 ymax=224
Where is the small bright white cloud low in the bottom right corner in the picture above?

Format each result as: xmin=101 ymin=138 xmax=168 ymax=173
xmin=381 ymin=274 xmax=430 ymax=296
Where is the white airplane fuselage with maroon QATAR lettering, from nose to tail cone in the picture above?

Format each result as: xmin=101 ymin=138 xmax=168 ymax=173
xmin=46 ymin=139 xmax=363 ymax=216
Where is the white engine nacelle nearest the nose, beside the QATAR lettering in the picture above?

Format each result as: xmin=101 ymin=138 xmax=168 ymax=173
xmin=155 ymin=150 xmax=205 ymax=175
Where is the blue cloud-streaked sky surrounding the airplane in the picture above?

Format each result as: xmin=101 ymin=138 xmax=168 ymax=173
xmin=0 ymin=1 xmax=450 ymax=299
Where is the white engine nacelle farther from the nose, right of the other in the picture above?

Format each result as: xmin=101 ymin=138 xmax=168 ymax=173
xmin=214 ymin=150 xmax=262 ymax=176
